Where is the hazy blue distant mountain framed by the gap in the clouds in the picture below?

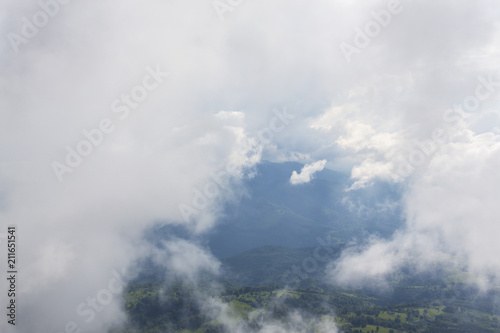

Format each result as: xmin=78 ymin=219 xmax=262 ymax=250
xmin=208 ymin=162 xmax=402 ymax=258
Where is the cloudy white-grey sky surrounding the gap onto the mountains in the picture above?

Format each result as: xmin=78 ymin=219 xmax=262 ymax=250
xmin=0 ymin=0 xmax=500 ymax=333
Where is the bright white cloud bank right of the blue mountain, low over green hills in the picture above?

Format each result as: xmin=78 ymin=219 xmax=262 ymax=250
xmin=332 ymin=131 xmax=500 ymax=288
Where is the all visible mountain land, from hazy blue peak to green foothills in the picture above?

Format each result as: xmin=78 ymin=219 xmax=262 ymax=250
xmin=122 ymin=162 xmax=500 ymax=333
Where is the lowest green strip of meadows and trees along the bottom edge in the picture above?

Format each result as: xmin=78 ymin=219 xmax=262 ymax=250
xmin=115 ymin=281 xmax=500 ymax=333
